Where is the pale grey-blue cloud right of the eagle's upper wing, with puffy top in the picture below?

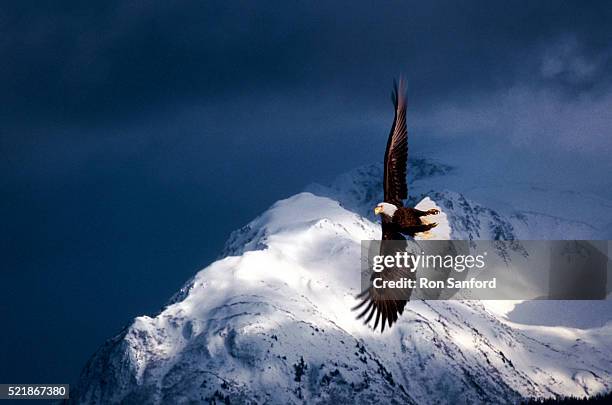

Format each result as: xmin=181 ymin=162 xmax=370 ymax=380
xmin=415 ymin=36 xmax=612 ymax=156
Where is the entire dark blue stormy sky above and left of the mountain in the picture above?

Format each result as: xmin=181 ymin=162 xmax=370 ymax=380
xmin=0 ymin=0 xmax=612 ymax=383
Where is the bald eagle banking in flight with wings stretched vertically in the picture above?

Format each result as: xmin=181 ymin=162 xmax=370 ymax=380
xmin=353 ymin=79 xmax=440 ymax=332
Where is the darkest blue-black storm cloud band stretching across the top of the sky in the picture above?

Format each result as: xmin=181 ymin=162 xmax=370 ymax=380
xmin=0 ymin=0 xmax=610 ymax=126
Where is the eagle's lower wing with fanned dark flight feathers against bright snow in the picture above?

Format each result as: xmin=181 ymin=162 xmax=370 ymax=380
xmin=353 ymin=223 xmax=414 ymax=332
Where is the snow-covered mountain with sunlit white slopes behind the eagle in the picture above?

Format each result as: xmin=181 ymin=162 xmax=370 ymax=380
xmin=71 ymin=159 xmax=612 ymax=404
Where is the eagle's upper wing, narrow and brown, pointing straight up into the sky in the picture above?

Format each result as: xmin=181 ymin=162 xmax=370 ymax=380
xmin=383 ymin=79 xmax=408 ymax=207
